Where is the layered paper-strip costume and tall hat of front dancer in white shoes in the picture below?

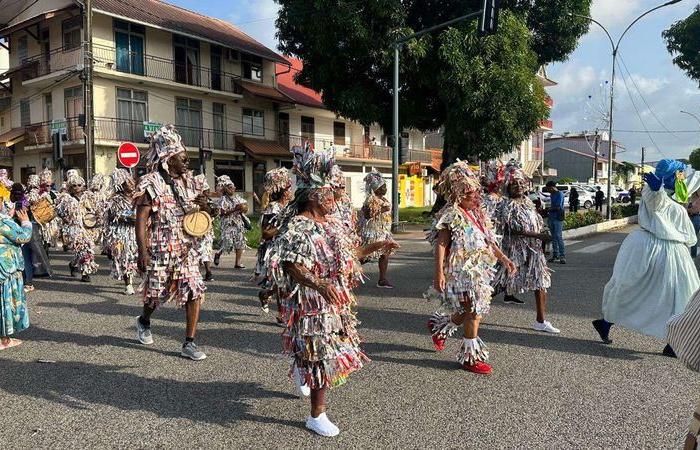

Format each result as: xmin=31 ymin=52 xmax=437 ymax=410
xmin=268 ymin=145 xmax=369 ymax=389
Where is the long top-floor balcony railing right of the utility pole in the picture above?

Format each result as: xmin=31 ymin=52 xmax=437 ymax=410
xmin=93 ymin=45 xmax=241 ymax=94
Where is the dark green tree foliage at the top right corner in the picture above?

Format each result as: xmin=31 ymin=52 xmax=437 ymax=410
xmin=663 ymin=5 xmax=700 ymax=84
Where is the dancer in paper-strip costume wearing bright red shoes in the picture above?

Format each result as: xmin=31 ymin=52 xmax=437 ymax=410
xmin=425 ymin=161 xmax=517 ymax=375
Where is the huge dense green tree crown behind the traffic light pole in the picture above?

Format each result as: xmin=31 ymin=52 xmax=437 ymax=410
xmin=277 ymin=0 xmax=591 ymax=165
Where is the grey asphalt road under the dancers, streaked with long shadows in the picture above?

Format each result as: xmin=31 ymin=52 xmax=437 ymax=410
xmin=0 ymin=230 xmax=700 ymax=449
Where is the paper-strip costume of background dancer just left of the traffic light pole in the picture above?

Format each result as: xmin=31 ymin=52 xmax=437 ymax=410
xmin=359 ymin=169 xmax=394 ymax=261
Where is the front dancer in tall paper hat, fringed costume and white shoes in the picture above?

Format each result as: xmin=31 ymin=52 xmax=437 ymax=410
xmin=268 ymin=145 xmax=397 ymax=436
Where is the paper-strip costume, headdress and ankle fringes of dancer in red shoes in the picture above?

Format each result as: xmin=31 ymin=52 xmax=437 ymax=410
xmin=425 ymin=162 xmax=497 ymax=364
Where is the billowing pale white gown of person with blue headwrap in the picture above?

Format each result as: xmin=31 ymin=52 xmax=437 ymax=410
xmin=603 ymin=186 xmax=700 ymax=339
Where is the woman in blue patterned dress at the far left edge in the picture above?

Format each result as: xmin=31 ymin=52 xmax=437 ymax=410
xmin=0 ymin=200 xmax=32 ymax=350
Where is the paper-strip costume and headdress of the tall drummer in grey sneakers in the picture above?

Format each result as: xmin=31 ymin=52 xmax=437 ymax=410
xmin=134 ymin=125 xmax=205 ymax=308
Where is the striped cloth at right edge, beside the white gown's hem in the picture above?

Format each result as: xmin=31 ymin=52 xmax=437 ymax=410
xmin=666 ymin=291 xmax=700 ymax=372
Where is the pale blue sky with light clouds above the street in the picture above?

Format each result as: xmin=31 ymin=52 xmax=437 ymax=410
xmin=168 ymin=0 xmax=700 ymax=162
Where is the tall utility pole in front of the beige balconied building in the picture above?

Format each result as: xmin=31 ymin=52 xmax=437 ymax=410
xmin=83 ymin=0 xmax=95 ymax=180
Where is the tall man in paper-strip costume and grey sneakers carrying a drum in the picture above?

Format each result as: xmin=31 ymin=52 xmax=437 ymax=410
xmin=134 ymin=125 xmax=209 ymax=361
